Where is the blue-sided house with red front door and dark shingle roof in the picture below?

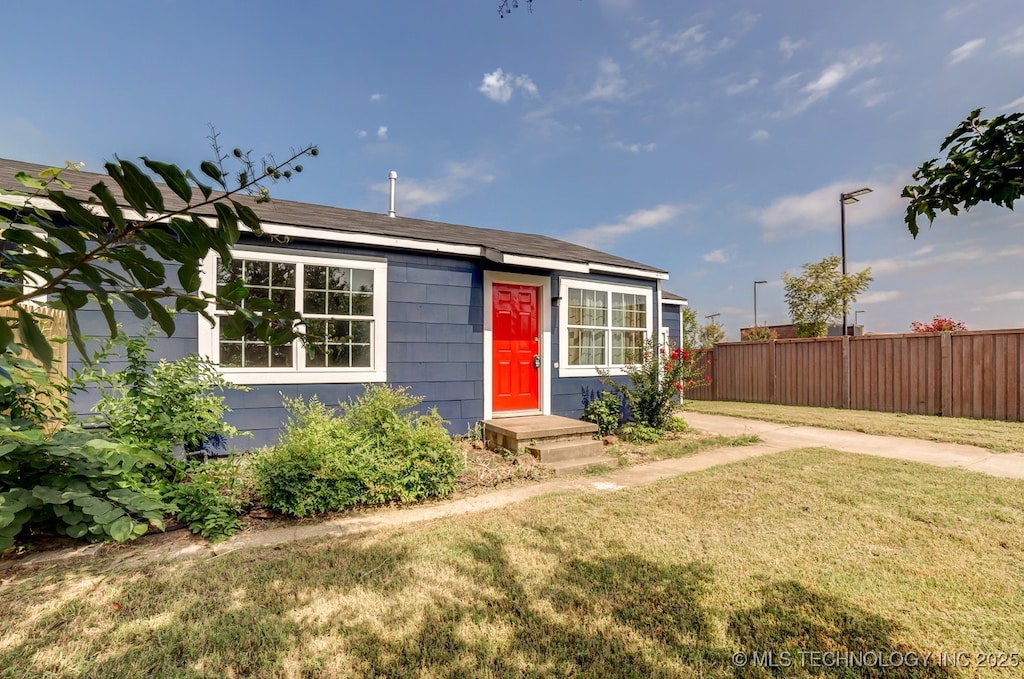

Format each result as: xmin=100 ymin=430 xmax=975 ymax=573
xmin=0 ymin=156 xmax=686 ymax=445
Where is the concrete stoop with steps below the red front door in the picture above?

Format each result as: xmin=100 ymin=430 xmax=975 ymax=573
xmin=483 ymin=415 xmax=615 ymax=476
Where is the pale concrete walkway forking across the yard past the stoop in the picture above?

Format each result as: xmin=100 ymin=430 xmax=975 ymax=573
xmin=9 ymin=413 xmax=1024 ymax=570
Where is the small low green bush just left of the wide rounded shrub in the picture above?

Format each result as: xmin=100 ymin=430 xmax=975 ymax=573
xmin=164 ymin=460 xmax=248 ymax=542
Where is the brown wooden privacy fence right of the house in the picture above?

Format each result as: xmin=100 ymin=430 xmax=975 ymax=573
xmin=686 ymin=329 xmax=1024 ymax=422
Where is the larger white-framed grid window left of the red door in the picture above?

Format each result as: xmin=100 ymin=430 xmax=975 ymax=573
xmin=200 ymin=250 xmax=387 ymax=384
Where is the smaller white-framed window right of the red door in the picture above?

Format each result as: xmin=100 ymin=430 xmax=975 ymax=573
xmin=559 ymin=279 xmax=653 ymax=376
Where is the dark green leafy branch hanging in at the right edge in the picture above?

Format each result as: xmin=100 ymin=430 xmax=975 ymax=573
xmin=902 ymin=109 xmax=1024 ymax=238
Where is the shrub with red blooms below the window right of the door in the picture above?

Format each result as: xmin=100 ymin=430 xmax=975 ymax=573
xmin=598 ymin=337 xmax=711 ymax=431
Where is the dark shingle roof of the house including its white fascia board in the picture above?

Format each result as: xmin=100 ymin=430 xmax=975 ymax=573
xmin=0 ymin=159 xmax=668 ymax=279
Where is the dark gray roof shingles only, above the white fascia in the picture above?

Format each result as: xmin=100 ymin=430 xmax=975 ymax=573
xmin=0 ymin=159 xmax=666 ymax=273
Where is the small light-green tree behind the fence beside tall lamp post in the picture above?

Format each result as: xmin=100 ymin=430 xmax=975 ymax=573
xmin=782 ymin=255 xmax=872 ymax=337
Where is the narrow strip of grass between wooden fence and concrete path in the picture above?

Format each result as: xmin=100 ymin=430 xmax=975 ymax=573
xmin=683 ymin=400 xmax=1024 ymax=453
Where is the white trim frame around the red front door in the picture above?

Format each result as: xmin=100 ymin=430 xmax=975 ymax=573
xmin=483 ymin=270 xmax=551 ymax=420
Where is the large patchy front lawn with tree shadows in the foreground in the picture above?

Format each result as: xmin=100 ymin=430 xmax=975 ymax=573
xmin=0 ymin=449 xmax=1024 ymax=677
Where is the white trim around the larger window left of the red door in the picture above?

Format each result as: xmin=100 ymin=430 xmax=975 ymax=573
xmin=199 ymin=248 xmax=387 ymax=384
